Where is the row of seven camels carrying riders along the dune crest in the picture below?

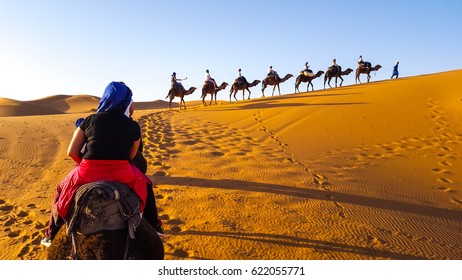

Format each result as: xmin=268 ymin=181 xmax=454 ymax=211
xmin=165 ymin=56 xmax=382 ymax=110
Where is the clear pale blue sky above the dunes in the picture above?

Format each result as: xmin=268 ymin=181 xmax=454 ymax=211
xmin=0 ymin=0 xmax=462 ymax=101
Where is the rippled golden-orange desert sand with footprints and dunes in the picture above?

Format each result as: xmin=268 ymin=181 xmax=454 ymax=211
xmin=0 ymin=70 xmax=462 ymax=260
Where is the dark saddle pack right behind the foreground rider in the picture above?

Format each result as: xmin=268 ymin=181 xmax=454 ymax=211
xmin=67 ymin=181 xmax=142 ymax=239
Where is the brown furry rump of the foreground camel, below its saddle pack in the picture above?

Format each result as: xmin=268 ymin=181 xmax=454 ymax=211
xmin=47 ymin=219 xmax=164 ymax=260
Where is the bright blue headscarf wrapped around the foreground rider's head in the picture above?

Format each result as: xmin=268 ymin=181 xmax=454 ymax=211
xmin=96 ymin=82 xmax=132 ymax=113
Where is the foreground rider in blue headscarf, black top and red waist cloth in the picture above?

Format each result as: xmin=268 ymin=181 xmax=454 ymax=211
xmin=41 ymin=82 xmax=163 ymax=246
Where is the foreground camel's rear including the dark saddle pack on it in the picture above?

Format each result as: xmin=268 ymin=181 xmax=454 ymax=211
xmin=47 ymin=181 xmax=164 ymax=260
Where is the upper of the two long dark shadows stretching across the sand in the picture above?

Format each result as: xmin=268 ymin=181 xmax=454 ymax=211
xmin=155 ymin=176 xmax=462 ymax=221
